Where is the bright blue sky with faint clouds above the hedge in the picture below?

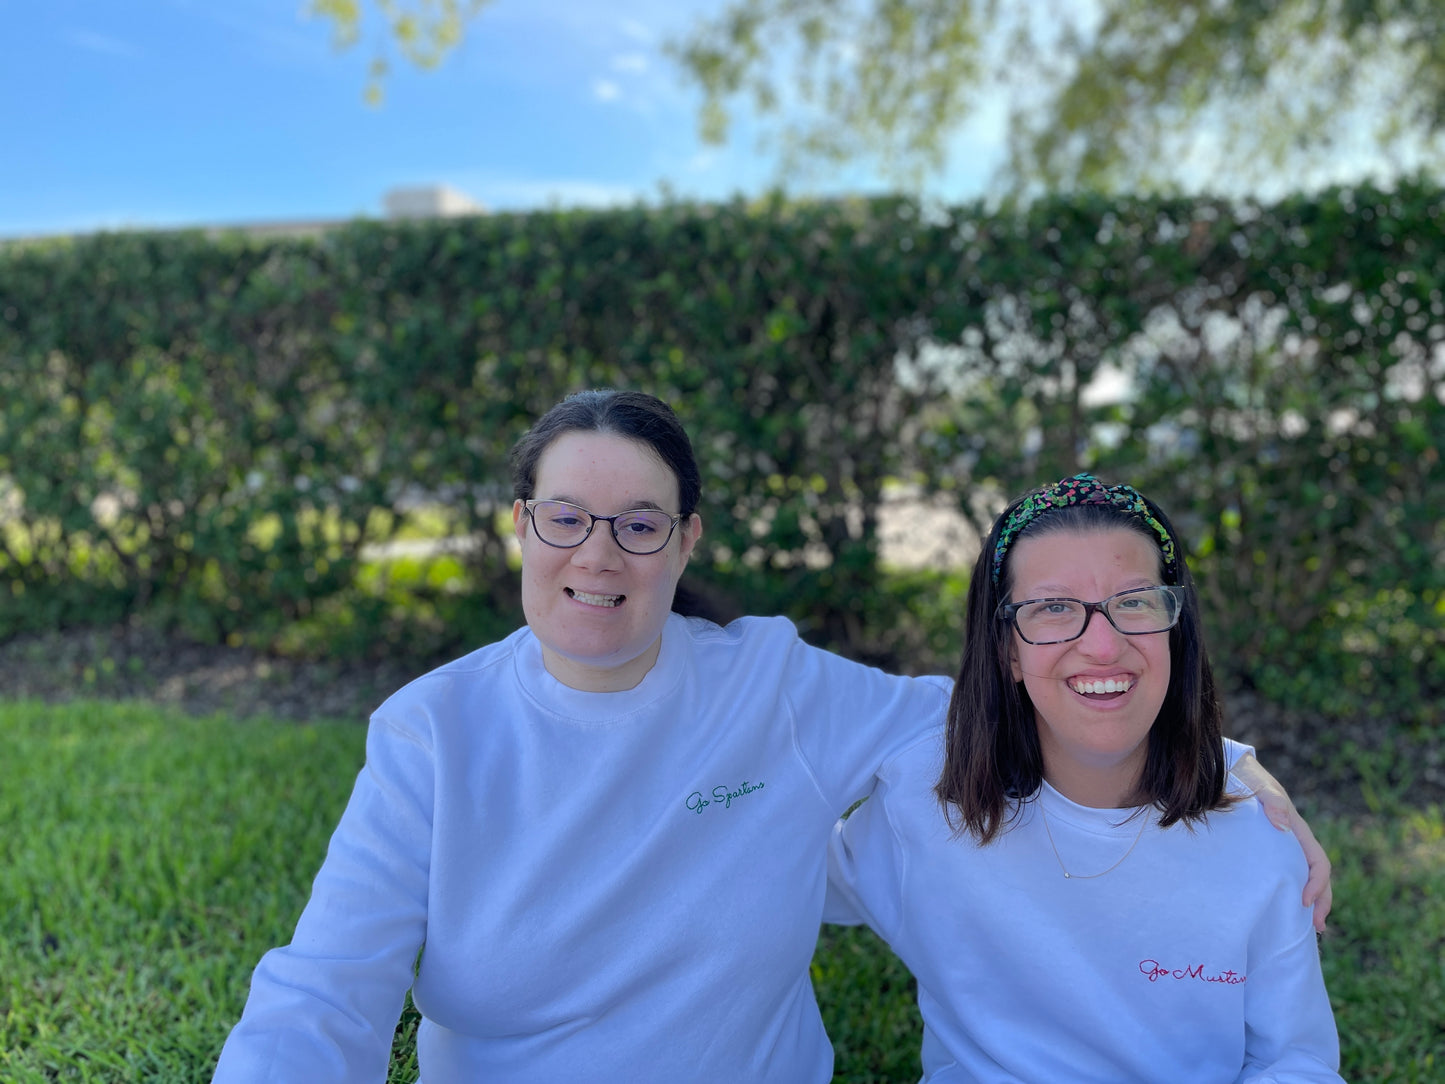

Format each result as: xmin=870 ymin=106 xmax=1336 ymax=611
xmin=0 ymin=0 xmax=1001 ymax=237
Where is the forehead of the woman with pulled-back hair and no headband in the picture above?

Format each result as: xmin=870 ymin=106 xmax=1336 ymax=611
xmin=535 ymin=431 xmax=678 ymax=512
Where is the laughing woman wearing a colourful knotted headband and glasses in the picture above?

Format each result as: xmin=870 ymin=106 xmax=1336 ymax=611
xmin=827 ymin=474 xmax=1340 ymax=1084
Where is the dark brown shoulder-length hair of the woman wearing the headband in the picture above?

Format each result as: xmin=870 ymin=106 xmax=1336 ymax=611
xmin=935 ymin=494 xmax=1233 ymax=843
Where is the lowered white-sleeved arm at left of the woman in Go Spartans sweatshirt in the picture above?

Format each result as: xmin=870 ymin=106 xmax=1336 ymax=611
xmin=214 ymin=705 xmax=434 ymax=1084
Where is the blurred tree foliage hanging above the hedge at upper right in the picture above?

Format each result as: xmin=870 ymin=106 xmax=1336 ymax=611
xmin=675 ymin=0 xmax=1445 ymax=191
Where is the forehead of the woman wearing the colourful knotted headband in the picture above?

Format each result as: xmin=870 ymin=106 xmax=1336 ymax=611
xmin=1010 ymin=528 xmax=1163 ymax=598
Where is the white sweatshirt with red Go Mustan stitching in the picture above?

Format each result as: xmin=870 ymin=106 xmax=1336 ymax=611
xmin=825 ymin=731 xmax=1340 ymax=1084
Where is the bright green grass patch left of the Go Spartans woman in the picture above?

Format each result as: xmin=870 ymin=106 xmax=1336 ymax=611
xmin=0 ymin=702 xmax=363 ymax=1081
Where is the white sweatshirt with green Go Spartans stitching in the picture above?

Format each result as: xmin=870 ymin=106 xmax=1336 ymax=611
xmin=215 ymin=616 xmax=949 ymax=1084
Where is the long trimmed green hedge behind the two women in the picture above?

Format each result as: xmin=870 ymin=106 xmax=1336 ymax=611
xmin=0 ymin=182 xmax=1445 ymax=727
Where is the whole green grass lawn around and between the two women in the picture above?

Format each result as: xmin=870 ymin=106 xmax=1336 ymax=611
xmin=0 ymin=701 xmax=1445 ymax=1084
